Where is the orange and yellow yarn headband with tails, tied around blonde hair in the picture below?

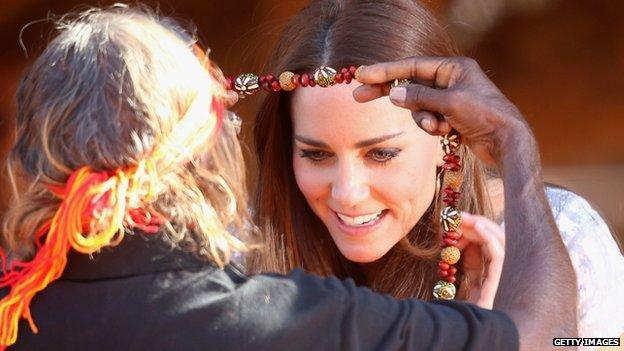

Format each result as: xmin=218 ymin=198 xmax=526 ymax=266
xmin=0 ymin=58 xmax=224 ymax=351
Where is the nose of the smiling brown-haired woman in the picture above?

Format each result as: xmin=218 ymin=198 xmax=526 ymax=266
xmin=331 ymin=164 xmax=370 ymax=209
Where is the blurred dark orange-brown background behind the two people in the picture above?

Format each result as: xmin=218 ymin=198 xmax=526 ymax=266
xmin=0 ymin=0 xmax=624 ymax=245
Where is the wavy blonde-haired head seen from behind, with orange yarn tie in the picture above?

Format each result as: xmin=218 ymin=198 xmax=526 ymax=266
xmin=0 ymin=6 xmax=252 ymax=346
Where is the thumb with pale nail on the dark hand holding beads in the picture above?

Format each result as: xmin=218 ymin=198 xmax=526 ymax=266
xmin=389 ymin=84 xmax=453 ymax=115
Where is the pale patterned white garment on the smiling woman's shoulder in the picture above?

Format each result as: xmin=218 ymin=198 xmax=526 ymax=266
xmin=546 ymin=188 xmax=624 ymax=350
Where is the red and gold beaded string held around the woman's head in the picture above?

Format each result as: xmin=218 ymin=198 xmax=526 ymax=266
xmin=226 ymin=66 xmax=463 ymax=300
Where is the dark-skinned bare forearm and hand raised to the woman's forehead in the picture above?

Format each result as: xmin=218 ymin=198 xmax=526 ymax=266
xmin=354 ymin=57 xmax=577 ymax=350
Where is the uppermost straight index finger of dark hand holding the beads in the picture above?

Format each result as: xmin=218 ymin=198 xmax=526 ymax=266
xmin=358 ymin=56 xmax=448 ymax=84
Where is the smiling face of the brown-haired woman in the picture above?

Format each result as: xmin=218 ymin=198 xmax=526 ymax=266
xmin=292 ymin=84 xmax=442 ymax=263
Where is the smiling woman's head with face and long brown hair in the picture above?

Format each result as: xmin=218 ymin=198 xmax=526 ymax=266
xmin=250 ymin=1 xmax=492 ymax=300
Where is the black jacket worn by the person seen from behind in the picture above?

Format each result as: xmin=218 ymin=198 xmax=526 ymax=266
xmin=0 ymin=235 xmax=518 ymax=351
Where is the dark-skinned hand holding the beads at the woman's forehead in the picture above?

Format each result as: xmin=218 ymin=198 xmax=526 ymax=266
xmin=353 ymin=57 xmax=532 ymax=165
